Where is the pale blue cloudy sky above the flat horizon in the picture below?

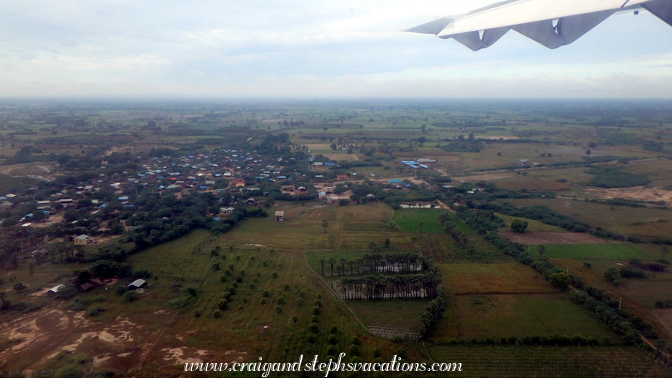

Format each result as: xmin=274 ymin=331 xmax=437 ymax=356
xmin=0 ymin=0 xmax=672 ymax=99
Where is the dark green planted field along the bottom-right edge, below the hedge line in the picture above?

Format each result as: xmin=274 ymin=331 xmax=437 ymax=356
xmin=429 ymin=346 xmax=672 ymax=378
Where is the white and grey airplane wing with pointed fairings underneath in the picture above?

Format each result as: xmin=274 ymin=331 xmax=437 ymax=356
xmin=407 ymin=0 xmax=672 ymax=51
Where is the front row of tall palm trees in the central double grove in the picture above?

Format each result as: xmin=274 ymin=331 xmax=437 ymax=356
xmin=333 ymin=270 xmax=441 ymax=299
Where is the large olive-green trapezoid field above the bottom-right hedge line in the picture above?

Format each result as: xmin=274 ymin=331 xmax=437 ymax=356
xmin=431 ymin=294 xmax=616 ymax=342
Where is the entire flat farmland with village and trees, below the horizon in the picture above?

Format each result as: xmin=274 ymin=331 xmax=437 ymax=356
xmin=0 ymin=102 xmax=672 ymax=378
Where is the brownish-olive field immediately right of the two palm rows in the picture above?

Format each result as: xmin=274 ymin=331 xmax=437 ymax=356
xmin=439 ymin=262 xmax=557 ymax=294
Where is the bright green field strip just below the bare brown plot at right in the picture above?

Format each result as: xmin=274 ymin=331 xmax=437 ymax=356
xmin=532 ymin=243 xmax=659 ymax=260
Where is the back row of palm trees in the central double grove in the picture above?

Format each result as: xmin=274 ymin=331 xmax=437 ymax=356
xmin=320 ymin=253 xmax=432 ymax=276
